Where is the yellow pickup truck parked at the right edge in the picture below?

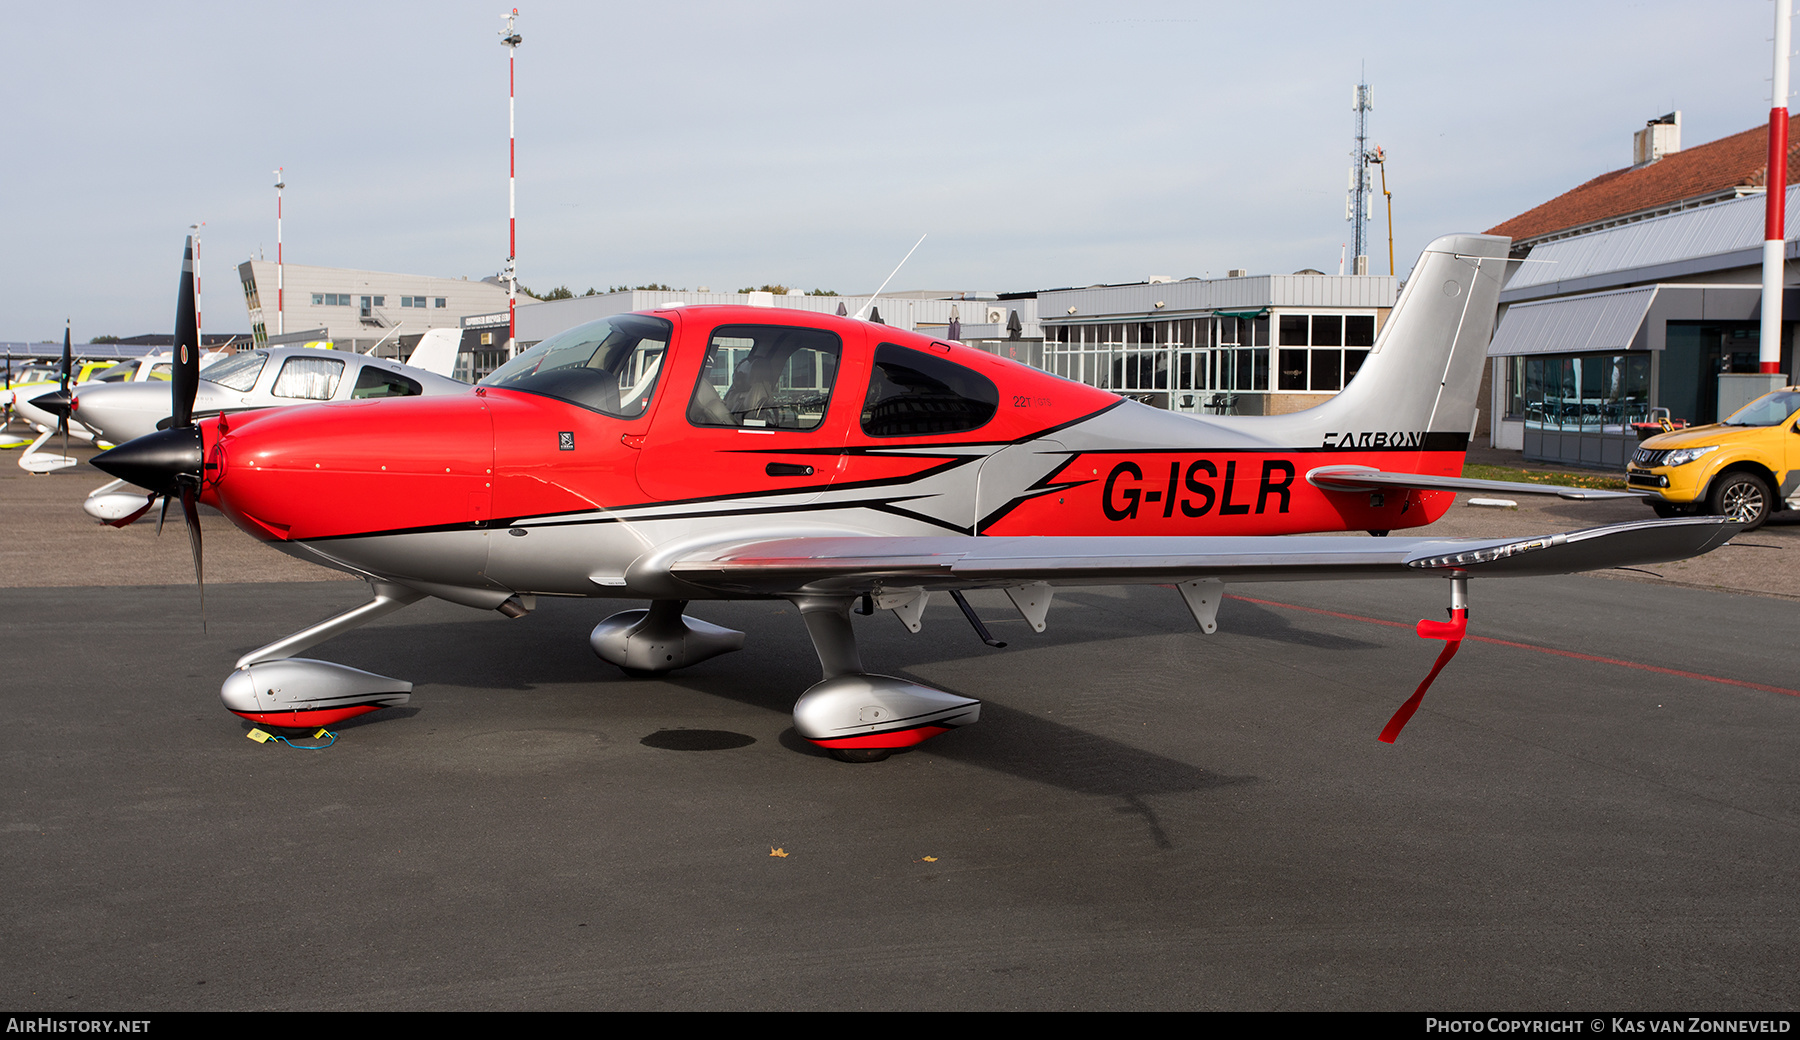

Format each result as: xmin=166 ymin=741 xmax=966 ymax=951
xmin=1625 ymin=387 xmax=1800 ymax=531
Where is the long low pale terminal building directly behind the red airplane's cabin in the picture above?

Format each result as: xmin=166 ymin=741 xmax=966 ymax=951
xmin=457 ymin=272 xmax=1399 ymax=416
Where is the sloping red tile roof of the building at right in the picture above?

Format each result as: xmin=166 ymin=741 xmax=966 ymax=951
xmin=1489 ymin=122 xmax=1800 ymax=241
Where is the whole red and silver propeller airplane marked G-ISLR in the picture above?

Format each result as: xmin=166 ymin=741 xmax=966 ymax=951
xmin=94 ymin=236 xmax=1737 ymax=761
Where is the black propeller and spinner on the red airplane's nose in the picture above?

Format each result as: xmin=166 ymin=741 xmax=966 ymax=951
xmin=90 ymin=236 xmax=207 ymax=624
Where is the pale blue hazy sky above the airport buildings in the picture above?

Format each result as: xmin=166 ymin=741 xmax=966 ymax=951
xmin=0 ymin=0 xmax=1773 ymax=340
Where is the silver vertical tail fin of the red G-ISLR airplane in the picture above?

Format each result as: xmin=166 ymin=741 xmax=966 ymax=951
xmin=1292 ymin=234 xmax=1512 ymax=452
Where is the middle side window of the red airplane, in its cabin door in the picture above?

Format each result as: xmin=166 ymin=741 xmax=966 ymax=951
xmin=688 ymin=326 xmax=844 ymax=430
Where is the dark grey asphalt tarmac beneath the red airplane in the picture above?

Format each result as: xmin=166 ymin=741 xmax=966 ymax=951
xmin=0 ymin=453 xmax=1800 ymax=1011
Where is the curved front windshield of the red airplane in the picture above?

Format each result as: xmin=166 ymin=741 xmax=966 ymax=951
xmin=479 ymin=315 xmax=675 ymax=419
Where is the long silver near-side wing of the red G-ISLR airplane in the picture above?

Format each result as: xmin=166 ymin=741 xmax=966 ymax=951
xmin=670 ymin=516 xmax=1742 ymax=596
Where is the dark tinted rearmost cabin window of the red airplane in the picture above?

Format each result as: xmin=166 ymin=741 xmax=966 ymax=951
xmin=862 ymin=344 xmax=1001 ymax=437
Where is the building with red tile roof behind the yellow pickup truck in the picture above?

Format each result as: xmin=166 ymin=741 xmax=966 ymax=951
xmin=1489 ymin=113 xmax=1800 ymax=468
